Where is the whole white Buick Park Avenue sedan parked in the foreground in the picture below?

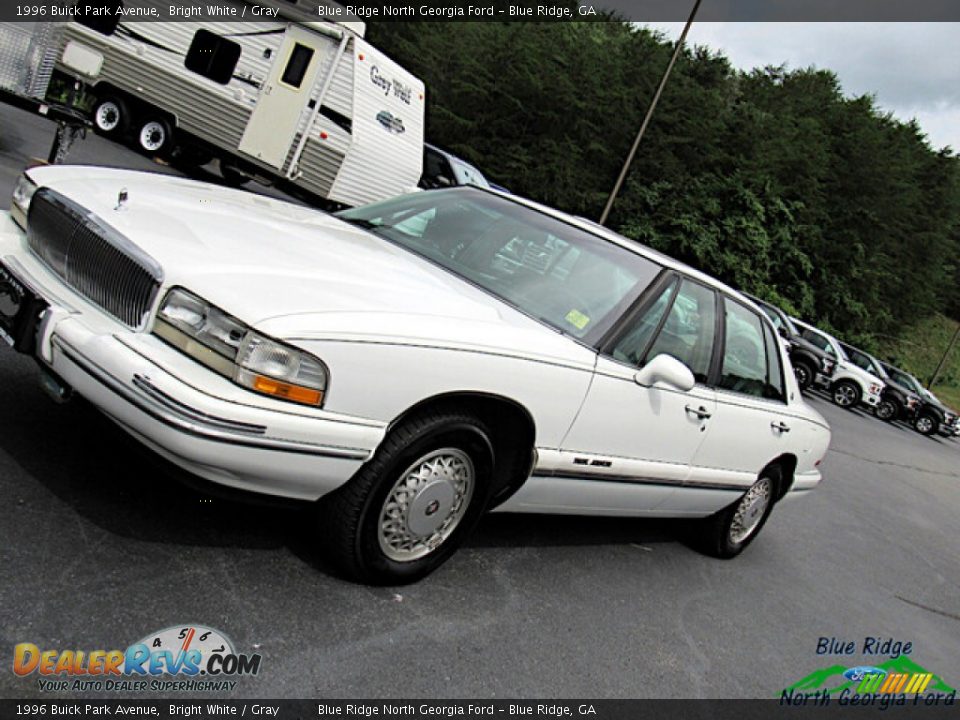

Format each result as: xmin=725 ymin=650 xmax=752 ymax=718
xmin=0 ymin=166 xmax=830 ymax=583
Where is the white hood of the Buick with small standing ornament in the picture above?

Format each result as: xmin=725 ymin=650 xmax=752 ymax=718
xmin=30 ymin=166 xmax=595 ymax=364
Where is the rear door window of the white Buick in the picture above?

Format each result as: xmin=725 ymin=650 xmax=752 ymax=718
xmin=718 ymin=300 xmax=783 ymax=400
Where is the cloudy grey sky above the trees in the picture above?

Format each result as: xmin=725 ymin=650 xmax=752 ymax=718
xmin=649 ymin=22 xmax=960 ymax=152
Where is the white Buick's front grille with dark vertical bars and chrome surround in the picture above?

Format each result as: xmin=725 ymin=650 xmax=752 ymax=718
xmin=27 ymin=188 xmax=163 ymax=328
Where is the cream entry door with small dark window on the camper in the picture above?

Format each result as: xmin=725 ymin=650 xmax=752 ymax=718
xmin=239 ymin=25 xmax=331 ymax=168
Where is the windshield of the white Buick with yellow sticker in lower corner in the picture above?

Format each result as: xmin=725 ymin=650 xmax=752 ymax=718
xmin=337 ymin=188 xmax=661 ymax=342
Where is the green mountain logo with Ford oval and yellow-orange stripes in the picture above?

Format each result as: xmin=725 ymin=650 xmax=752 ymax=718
xmin=784 ymin=655 xmax=956 ymax=695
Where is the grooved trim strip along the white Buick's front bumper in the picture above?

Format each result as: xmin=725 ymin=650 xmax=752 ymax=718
xmin=53 ymin=336 xmax=370 ymax=460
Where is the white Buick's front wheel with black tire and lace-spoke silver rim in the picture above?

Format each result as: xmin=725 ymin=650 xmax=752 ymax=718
xmin=319 ymin=412 xmax=494 ymax=585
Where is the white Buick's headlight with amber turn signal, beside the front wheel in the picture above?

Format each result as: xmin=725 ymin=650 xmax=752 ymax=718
xmin=153 ymin=288 xmax=329 ymax=406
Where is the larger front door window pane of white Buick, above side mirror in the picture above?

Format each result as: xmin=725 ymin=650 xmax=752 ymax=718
xmin=643 ymin=280 xmax=717 ymax=382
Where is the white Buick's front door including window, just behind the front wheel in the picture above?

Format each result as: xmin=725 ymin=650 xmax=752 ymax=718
xmin=556 ymin=278 xmax=717 ymax=513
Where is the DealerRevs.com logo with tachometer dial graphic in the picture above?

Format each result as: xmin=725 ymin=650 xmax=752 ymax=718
xmin=13 ymin=624 xmax=261 ymax=692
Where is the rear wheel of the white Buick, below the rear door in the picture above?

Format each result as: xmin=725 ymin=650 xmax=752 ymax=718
xmin=700 ymin=466 xmax=782 ymax=559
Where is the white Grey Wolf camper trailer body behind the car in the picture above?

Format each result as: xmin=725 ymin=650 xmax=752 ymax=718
xmin=58 ymin=0 xmax=425 ymax=205
